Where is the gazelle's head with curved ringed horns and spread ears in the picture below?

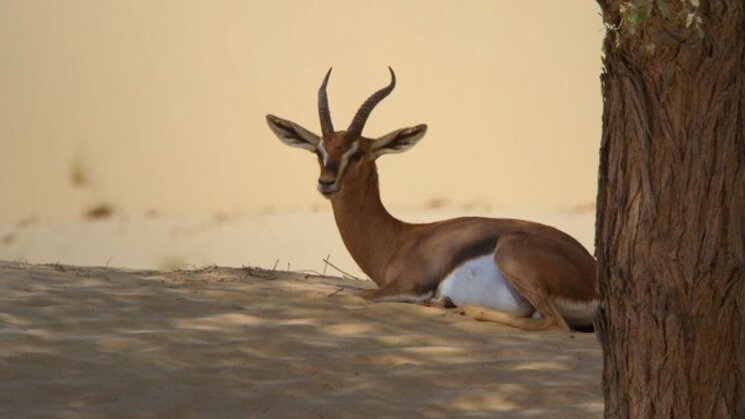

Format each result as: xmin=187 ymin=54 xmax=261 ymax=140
xmin=266 ymin=67 xmax=427 ymax=198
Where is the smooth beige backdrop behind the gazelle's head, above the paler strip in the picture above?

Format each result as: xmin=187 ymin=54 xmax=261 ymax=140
xmin=0 ymin=0 xmax=603 ymax=223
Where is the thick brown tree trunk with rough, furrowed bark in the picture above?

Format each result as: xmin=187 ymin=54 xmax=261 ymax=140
xmin=596 ymin=0 xmax=745 ymax=418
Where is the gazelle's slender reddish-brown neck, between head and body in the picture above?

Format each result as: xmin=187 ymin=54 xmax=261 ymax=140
xmin=331 ymin=168 xmax=404 ymax=285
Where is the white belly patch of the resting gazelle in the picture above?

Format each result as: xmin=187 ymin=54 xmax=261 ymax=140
xmin=435 ymin=253 xmax=534 ymax=316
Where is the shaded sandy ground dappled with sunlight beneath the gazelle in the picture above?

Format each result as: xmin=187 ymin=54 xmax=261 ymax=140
xmin=0 ymin=262 xmax=603 ymax=418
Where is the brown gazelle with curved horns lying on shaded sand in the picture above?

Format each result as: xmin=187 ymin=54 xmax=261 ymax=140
xmin=266 ymin=67 xmax=598 ymax=330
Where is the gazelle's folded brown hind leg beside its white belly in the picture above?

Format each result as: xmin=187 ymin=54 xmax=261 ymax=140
xmin=476 ymin=235 xmax=569 ymax=330
